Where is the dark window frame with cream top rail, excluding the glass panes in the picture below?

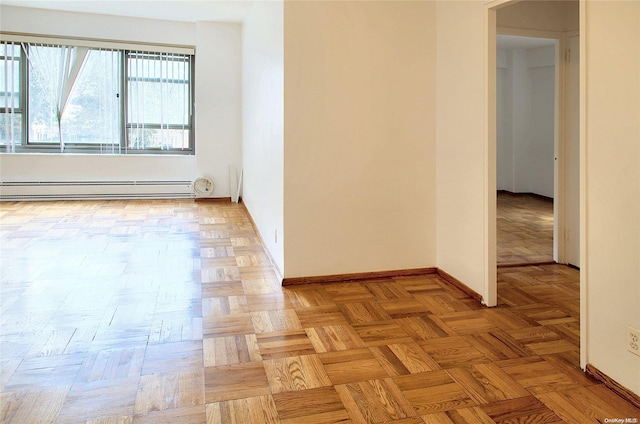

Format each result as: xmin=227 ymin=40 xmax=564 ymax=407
xmin=0 ymin=34 xmax=195 ymax=155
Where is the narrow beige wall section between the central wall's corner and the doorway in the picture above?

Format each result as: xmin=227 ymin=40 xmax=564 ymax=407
xmin=436 ymin=1 xmax=495 ymax=299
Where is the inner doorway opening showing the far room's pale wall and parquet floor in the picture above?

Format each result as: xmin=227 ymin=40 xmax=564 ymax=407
xmin=496 ymin=34 xmax=562 ymax=267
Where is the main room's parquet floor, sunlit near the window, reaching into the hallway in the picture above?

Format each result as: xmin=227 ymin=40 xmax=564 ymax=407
xmin=0 ymin=201 xmax=640 ymax=424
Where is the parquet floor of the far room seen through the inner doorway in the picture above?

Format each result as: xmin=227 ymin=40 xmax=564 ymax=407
xmin=496 ymin=191 xmax=553 ymax=265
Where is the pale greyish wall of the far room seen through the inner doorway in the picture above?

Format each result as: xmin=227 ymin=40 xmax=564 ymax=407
xmin=496 ymin=46 xmax=555 ymax=198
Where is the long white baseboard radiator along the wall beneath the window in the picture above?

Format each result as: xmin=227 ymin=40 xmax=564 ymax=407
xmin=0 ymin=181 xmax=194 ymax=201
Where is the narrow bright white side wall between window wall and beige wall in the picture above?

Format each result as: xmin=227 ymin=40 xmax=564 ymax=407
xmin=242 ymin=1 xmax=284 ymax=272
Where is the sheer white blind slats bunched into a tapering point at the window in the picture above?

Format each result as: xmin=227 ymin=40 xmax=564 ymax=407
xmin=23 ymin=44 xmax=89 ymax=152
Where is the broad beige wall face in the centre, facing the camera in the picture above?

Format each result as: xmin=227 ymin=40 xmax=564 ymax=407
xmin=284 ymin=1 xmax=436 ymax=277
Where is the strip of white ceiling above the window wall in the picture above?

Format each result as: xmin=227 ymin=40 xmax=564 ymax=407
xmin=2 ymin=0 xmax=253 ymax=22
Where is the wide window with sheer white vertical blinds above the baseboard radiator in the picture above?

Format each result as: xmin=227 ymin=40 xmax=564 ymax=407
xmin=0 ymin=42 xmax=194 ymax=154
